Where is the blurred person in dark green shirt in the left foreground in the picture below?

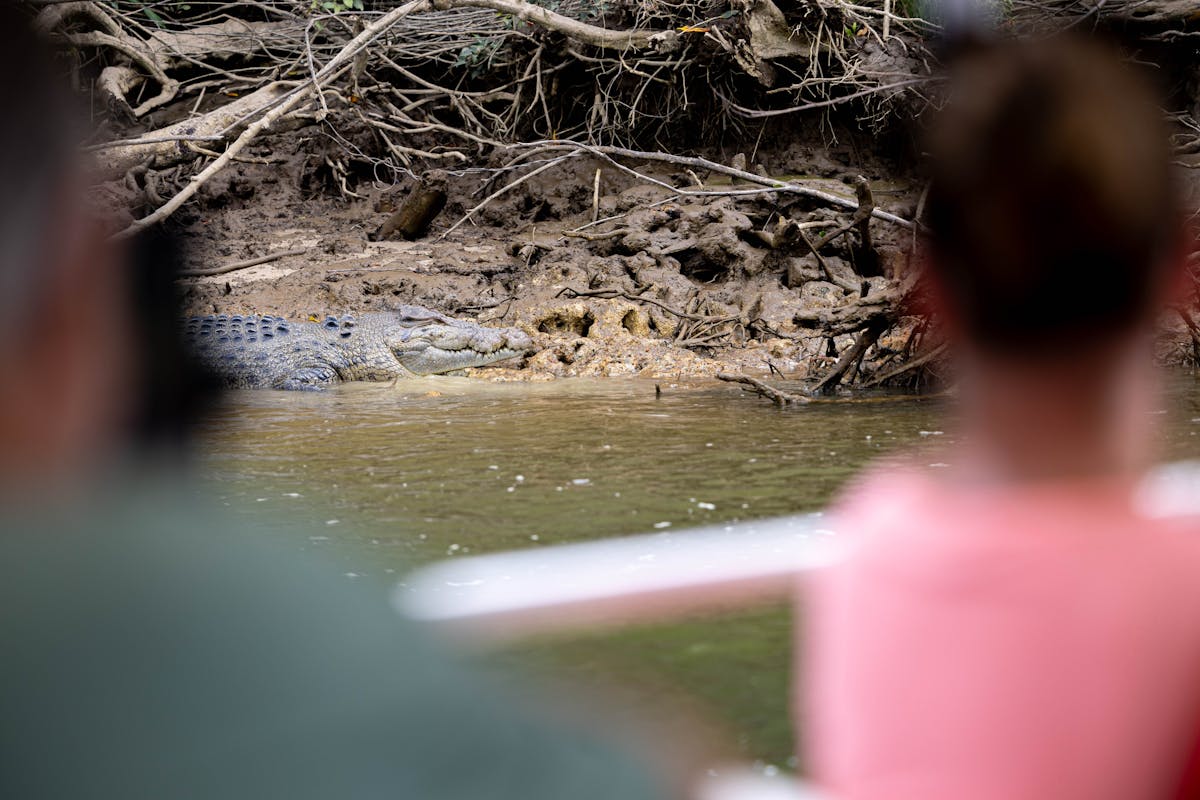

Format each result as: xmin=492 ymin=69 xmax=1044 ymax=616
xmin=0 ymin=5 xmax=661 ymax=800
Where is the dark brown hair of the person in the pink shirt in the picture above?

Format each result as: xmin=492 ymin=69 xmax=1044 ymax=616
xmin=928 ymin=37 xmax=1181 ymax=355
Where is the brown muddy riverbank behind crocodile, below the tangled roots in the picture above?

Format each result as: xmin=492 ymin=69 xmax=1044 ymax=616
xmin=175 ymin=130 xmax=936 ymax=380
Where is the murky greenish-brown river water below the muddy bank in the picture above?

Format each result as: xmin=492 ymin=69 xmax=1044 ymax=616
xmin=202 ymin=377 xmax=1200 ymax=765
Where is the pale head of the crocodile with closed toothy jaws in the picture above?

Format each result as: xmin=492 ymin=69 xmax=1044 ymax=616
xmin=386 ymin=306 xmax=533 ymax=375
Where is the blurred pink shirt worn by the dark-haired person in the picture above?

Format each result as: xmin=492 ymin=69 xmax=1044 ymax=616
xmin=798 ymin=469 xmax=1200 ymax=800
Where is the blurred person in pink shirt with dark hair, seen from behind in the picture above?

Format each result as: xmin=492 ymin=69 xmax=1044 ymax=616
xmin=800 ymin=40 xmax=1200 ymax=800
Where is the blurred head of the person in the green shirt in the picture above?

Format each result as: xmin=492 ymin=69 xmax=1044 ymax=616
xmin=0 ymin=4 xmax=133 ymax=483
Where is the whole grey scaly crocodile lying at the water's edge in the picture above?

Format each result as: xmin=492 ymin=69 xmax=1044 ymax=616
xmin=184 ymin=306 xmax=533 ymax=390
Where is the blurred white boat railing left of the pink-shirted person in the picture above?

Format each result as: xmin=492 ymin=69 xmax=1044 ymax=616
xmin=392 ymin=515 xmax=841 ymax=800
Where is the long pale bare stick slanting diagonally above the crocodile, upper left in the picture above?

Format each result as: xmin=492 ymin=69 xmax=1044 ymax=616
xmin=113 ymin=0 xmax=430 ymax=240
